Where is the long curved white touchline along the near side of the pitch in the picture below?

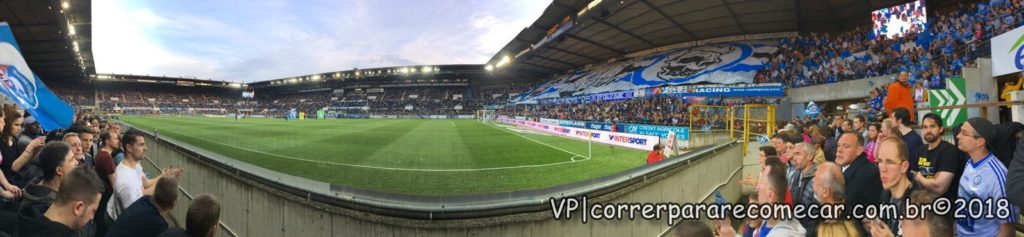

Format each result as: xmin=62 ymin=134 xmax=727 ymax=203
xmin=149 ymin=126 xmax=590 ymax=172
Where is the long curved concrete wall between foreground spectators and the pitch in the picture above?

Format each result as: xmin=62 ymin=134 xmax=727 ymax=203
xmin=136 ymin=130 xmax=743 ymax=236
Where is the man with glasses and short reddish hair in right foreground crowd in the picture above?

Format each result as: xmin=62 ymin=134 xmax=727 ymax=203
xmin=864 ymin=137 xmax=918 ymax=236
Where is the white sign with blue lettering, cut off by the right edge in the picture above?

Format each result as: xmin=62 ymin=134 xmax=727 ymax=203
xmin=992 ymin=27 xmax=1024 ymax=76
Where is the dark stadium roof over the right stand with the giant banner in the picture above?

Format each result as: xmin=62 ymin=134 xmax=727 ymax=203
xmin=487 ymin=0 xmax=953 ymax=77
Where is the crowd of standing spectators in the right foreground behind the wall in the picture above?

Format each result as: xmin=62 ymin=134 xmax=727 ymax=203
xmin=674 ymin=108 xmax=1024 ymax=236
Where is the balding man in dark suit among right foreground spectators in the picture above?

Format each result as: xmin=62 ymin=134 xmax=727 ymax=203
xmin=836 ymin=132 xmax=882 ymax=209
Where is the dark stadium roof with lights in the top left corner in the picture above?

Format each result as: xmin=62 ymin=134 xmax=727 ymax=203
xmin=0 ymin=0 xmax=96 ymax=81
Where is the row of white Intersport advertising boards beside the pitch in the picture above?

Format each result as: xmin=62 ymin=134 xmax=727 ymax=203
xmin=498 ymin=116 xmax=660 ymax=151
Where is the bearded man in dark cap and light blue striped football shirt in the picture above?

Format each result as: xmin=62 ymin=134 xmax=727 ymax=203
xmin=956 ymin=118 xmax=1020 ymax=236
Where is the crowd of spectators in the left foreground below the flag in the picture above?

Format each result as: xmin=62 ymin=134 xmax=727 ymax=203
xmin=0 ymin=105 xmax=220 ymax=237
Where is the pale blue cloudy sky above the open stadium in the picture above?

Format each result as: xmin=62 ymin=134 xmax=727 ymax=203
xmin=92 ymin=0 xmax=551 ymax=82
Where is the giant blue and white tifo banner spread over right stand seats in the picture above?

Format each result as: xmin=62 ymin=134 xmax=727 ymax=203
xmin=511 ymin=41 xmax=778 ymax=104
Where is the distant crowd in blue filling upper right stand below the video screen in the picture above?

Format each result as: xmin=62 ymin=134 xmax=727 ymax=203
xmin=755 ymin=0 xmax=1024 ymax=87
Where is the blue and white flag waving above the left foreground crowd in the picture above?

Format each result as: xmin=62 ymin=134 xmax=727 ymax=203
xmin=0 ymin=23 xmax=75 ymax=130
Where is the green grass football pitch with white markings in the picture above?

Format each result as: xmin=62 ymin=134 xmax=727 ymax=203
xmin=122 ymin=117 xmax=646 ymax=196
